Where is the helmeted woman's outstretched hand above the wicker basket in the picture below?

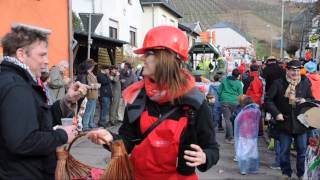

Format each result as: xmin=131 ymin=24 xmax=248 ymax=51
xmin=87 ymin=129 xmax=113 ymax=146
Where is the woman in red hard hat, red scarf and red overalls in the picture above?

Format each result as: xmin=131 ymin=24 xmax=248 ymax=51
xmin=88 ymin=26 xmax=219 ymax=180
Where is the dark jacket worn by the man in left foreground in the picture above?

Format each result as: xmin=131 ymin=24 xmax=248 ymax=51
xmin=0 ymin=61 xmax=69 ymax=179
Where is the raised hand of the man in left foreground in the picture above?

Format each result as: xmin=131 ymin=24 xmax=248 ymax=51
xmin=65 ymin=81 xmax=88 ymax=103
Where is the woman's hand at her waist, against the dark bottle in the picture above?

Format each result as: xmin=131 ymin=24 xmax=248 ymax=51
xmin=184 ymin=144 xmax=207 ymax=167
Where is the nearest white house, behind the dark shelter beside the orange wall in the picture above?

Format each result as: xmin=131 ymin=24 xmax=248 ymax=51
xmin=72 ymin=0 xmax=144 ymax=54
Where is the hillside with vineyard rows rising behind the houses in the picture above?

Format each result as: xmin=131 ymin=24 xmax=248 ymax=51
xmin=171 ymin=0 xmax=301 ymax=42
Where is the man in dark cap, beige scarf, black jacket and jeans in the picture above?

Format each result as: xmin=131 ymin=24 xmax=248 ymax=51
xmin=265 ymin=60 xmax=313 ymax=178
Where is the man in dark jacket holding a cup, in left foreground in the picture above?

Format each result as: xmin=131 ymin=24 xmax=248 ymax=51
xmin=0 ymin=25 xmax=86 ymax=179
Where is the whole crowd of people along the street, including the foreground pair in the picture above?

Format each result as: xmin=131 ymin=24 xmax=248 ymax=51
xmin=0 ymin=25 xmax=320 ymax=179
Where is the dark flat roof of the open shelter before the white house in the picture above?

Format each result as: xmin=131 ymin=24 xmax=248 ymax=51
xmin=73 ymin=31 xmax=128 ymax=48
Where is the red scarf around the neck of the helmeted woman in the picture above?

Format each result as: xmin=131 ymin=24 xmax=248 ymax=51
xmin=122 ymin=70 xmax=195 ymax=104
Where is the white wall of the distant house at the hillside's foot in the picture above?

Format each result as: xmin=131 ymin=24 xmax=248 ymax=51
xmin=208 ymin=28 xmax=250 ymax=47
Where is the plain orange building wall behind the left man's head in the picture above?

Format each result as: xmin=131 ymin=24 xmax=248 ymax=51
xmin=0 ymin=0 xmax=69 ymax=66
